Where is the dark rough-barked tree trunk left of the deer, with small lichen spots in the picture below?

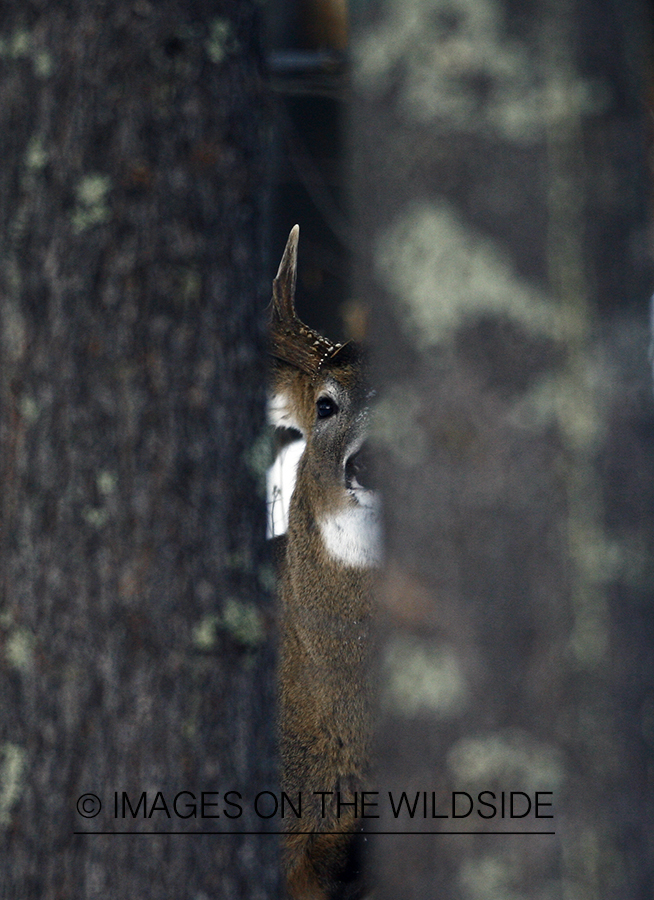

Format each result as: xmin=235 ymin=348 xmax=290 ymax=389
xmin=0 ymin=0 xmax=277 ymax=900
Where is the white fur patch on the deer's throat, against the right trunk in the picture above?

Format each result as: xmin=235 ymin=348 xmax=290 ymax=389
xmin=318 ymin=500 xmax=381 ymax=569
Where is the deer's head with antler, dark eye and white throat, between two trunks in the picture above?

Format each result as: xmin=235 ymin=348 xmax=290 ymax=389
xmin=269 ymin=225 xmax=379 ymax=566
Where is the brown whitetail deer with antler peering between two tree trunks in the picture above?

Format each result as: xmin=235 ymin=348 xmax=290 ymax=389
xmin=270 ymin=225 xmax=379 ymax=900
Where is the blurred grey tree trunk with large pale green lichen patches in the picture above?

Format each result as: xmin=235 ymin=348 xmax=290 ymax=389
xmin=352 ymin=0 xmax=654 ymax=900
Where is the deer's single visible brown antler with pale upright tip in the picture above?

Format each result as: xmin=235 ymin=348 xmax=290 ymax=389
xmin=270 ymin=225 xmax=343 ymax=378
